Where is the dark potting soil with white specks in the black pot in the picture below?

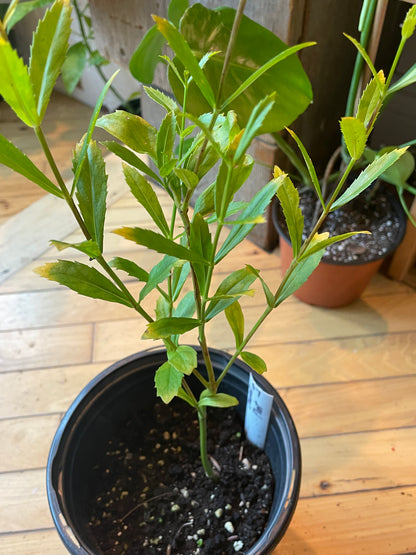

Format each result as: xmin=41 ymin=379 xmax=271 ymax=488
xmin=90 ymin=401 xmax=274 ymax=555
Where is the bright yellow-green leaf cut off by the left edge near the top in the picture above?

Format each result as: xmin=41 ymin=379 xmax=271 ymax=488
xmin=0 ymin=37 xmax=39 ymax=127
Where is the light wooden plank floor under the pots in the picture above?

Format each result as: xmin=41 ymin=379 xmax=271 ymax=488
xmin=0 ymin=93 xmax=416 ymax=555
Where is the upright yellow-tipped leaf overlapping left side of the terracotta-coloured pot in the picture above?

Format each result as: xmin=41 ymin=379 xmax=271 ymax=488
xmin=275 ymin=174 xmax=303 ymax=256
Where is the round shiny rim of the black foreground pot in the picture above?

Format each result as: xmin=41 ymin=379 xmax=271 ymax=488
xmin=46 ymin=346 xmax=302 ymax=555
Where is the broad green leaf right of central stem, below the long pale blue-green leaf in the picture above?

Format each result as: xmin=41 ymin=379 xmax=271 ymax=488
xmin=205 ymin=268 xmax=256 ymax=321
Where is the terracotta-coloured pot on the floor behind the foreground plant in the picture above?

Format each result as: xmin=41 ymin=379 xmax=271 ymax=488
xmin=272 ymin=194 xmax=406 ymax=308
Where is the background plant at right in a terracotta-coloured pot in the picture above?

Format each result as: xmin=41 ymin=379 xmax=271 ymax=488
xmin=273 ymin=1 xmax=416 ymax=307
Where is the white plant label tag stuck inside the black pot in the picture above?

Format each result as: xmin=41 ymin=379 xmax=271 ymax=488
xmin=244 ymin=374 xmax=273 ymax=449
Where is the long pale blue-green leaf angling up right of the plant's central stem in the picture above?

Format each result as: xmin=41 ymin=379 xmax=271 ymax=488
xmin=215 ymin=181 xmax=278 ymax=263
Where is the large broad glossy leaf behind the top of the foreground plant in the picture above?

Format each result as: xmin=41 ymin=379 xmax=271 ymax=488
xmin=169 ymin=4 xmax=312 ymax=133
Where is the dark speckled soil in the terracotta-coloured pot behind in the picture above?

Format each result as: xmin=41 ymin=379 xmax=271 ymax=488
xmin=286 ymin=190 xmax=401 ymax=264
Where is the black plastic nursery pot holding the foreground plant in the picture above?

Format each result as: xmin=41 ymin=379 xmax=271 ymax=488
xmin=47 ymin=349 xmax=301 ymax=555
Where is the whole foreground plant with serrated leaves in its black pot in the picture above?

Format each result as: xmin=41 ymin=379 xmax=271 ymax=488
xmin=0 ymin=0 xmax=410 ymax=555
